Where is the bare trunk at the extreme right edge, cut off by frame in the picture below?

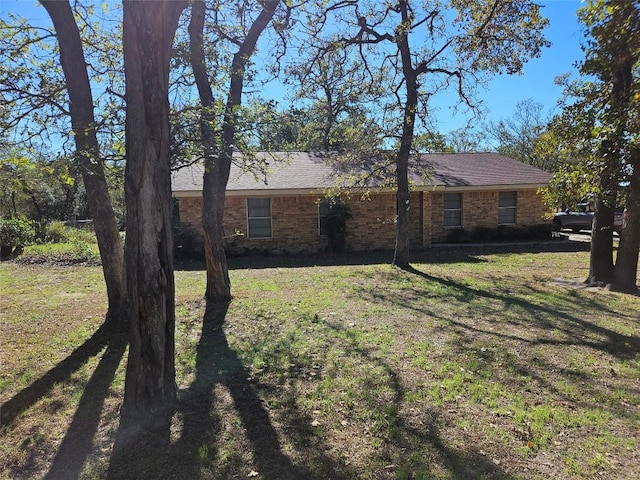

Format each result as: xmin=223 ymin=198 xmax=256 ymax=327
xmin=613 ymin=150 xmax=640 ymax=293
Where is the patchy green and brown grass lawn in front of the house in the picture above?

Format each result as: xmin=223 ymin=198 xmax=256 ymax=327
xmin=0 ymin=249 xmax=640 ymax=480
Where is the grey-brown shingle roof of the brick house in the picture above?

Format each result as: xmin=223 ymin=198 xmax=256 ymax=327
xmin=172 ymin=152 xmax=550 ymax=193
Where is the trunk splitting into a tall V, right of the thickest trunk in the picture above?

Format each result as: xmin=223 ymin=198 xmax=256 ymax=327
xmin=189 ymin=0 xmax=280 ymax=303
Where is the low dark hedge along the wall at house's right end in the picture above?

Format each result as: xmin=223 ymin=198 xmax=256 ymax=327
xmin=446 ymin=223 xmax=553 ymax=243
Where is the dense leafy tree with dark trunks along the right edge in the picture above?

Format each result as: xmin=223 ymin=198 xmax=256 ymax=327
xmin=565 ymin=0 xmax=640 ymax=292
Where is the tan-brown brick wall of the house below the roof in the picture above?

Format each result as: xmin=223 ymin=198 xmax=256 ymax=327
xmin=179 ymin=190 xmax=546 ymax=253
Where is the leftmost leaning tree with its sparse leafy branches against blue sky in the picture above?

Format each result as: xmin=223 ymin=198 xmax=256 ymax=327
xmin=0 ymin=0 xmax=126 ymax=324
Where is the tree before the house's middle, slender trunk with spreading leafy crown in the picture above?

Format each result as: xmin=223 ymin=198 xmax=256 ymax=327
xmin=305 ymin=0 xmax=547 ymax=268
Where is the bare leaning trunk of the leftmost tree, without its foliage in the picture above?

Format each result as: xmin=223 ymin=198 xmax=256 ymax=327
xmin=40 ymin=0 xmax=127 ymax=325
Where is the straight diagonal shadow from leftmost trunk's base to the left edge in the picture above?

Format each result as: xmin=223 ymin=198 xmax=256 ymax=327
xmin=0 ymin=324 xmax=126 ymax=426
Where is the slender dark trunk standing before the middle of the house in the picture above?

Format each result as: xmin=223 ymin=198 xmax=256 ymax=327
xmin=393 ymin=2 xmax=418 ymax=268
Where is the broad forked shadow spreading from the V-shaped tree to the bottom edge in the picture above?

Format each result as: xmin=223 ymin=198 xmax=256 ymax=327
xmin=107 ymin=304 xmax=344 ymax=480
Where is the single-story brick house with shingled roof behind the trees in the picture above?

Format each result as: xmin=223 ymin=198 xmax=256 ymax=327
xmin=172 ymin=152 xmax=550 ymax=253
